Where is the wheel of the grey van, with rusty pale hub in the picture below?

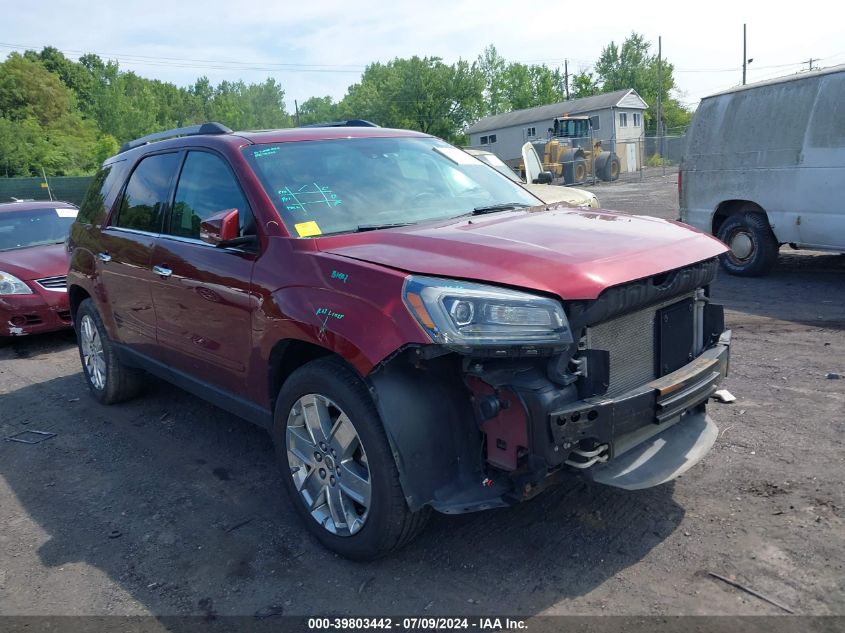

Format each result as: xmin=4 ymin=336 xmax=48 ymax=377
xmin=718 ymin=211 xmax=780 ymax=277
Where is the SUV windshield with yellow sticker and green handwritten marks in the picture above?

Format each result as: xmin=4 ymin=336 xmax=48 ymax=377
xmin=243 ymin=138 xmax=540 ymax=237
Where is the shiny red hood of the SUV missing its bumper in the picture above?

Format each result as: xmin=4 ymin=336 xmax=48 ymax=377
xmin=317 ymin=207 xmax=727 ymax=299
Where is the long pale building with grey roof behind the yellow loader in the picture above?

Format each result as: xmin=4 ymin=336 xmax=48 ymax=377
xmin=467 ymin=89 xmax=648 ymax=171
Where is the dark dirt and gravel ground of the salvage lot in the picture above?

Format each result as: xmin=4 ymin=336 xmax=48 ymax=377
xmin=0 ymin=176 xmax=845 ymax=616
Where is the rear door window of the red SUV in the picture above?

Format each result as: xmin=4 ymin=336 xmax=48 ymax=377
xmin=112 ymin=153 xmax=179 ymax=233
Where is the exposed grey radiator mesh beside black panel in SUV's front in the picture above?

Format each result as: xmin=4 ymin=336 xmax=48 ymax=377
xmin=587 ymin=294 xmax=692 ymax=398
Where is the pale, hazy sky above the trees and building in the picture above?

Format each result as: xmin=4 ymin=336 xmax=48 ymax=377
xmin=0 ymin=0 xmax=845 ymax=111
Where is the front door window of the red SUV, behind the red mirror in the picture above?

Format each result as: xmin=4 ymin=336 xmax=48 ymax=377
xmin=167 ymin=152 xmax=250 ymax=239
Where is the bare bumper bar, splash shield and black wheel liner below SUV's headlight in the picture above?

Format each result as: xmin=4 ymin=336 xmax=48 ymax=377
xmin=368 ymin=331 xmax=731 ymax=514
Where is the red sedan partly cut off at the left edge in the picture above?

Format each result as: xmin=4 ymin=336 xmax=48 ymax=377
xmin=0 ymin=201 xmax=78 ymax=338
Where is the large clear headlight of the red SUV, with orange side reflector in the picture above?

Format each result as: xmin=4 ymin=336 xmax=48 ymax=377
xmin=402 ymin=275 xmax=572 ymax=356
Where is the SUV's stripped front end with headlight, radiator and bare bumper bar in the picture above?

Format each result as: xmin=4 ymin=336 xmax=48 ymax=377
xmin=369 ymin=259 xmax=730 ymax=513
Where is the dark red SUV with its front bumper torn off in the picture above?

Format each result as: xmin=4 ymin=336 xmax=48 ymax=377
xmin=68 ymin=123 xmax=730 ymax=559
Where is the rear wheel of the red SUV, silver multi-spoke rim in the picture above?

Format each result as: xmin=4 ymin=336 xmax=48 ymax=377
xmin=74 ymin=299 xmax=144 ymax=404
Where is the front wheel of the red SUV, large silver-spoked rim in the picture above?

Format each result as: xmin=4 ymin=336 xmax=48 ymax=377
xmin=273 ymin=358 xmax=431 ymax=560
